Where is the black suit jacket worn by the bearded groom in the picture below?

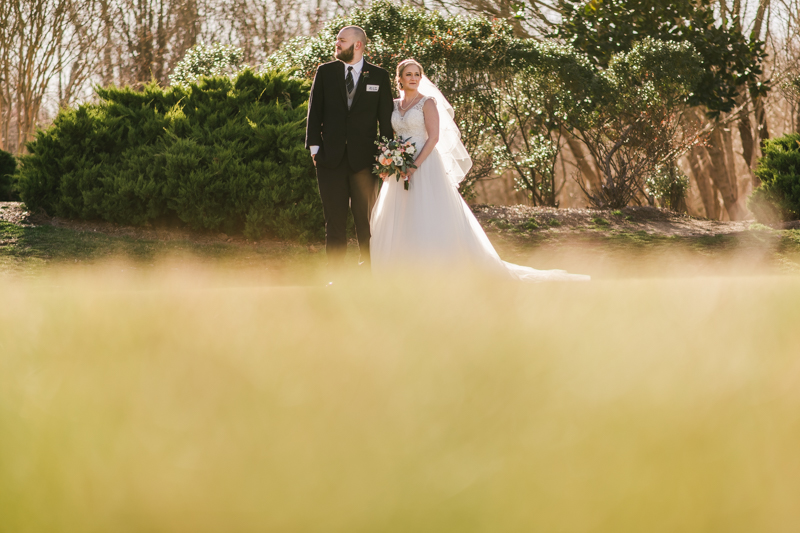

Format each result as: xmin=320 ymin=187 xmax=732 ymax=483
xmin=306 ymin=60 xmax=394 ymax=171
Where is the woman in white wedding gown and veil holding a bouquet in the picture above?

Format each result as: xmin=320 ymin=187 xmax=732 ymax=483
xmin=370 ymin=59 xmax=589 ymax=281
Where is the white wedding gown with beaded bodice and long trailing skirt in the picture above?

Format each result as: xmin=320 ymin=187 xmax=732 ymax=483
xmin=370 ymin=97 xmax=589 ymax=281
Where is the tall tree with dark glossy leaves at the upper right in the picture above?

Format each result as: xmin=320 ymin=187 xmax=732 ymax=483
xmin=552 ymin=0 xmax=769 ymax=219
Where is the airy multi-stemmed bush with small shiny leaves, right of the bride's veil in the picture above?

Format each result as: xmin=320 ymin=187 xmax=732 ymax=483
xmin=566 ymin=38 xmax=702 ymax=209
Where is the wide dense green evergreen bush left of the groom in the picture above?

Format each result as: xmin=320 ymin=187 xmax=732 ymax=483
xmin=19 ymin=70 xmax=323 ymax=239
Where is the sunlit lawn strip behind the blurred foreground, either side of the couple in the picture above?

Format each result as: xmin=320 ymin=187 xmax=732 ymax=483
xmin=0 ymin=218 xmax=800 ymax=283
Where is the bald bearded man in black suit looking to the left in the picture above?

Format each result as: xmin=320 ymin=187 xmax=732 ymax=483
xmin=306 ymin=26 xmax=394 ymax=266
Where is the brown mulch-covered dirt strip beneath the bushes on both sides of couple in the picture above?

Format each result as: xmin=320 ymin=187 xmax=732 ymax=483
xmin=6 ymin=202 xmax=800 ymax=244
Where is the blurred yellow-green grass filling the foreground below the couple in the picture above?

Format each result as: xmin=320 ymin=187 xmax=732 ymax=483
xmin=0 ymin=266 xmax=800 ymax=533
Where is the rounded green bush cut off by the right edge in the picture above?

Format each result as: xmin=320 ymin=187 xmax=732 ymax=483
xmin=747 ymin=133 xmax=800 ymax=223
